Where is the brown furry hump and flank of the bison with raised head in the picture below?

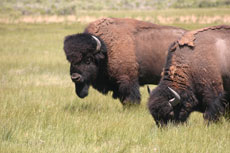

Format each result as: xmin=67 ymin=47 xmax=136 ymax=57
xmin=85 ymin=18 xmax=185 ymax=84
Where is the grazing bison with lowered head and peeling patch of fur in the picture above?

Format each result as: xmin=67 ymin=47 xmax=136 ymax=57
xmin=148 ymin=25 xmax=230 ymax=126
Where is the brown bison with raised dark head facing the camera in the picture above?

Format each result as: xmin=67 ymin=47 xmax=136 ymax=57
xmin=64 ymin=18 xmax=185 ymax=104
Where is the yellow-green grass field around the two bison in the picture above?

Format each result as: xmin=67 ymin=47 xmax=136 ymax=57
xmin=0 ymin=10 xmax=230 ymax=153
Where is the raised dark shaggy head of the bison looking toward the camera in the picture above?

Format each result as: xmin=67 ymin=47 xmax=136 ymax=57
xmin=64 ymin=33 xmax=105 ymax=98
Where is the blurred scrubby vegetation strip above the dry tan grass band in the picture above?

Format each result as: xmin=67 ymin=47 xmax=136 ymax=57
xmin=0 ymin=0 xmax=230 ymax=15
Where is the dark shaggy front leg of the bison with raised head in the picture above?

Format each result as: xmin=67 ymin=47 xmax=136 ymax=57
xmin=118 ymin=81 xmax=141 ymax=105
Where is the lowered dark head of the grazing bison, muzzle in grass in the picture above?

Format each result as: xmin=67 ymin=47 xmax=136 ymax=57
xmin=148 ymin=85 xmax=188 ymax=126
